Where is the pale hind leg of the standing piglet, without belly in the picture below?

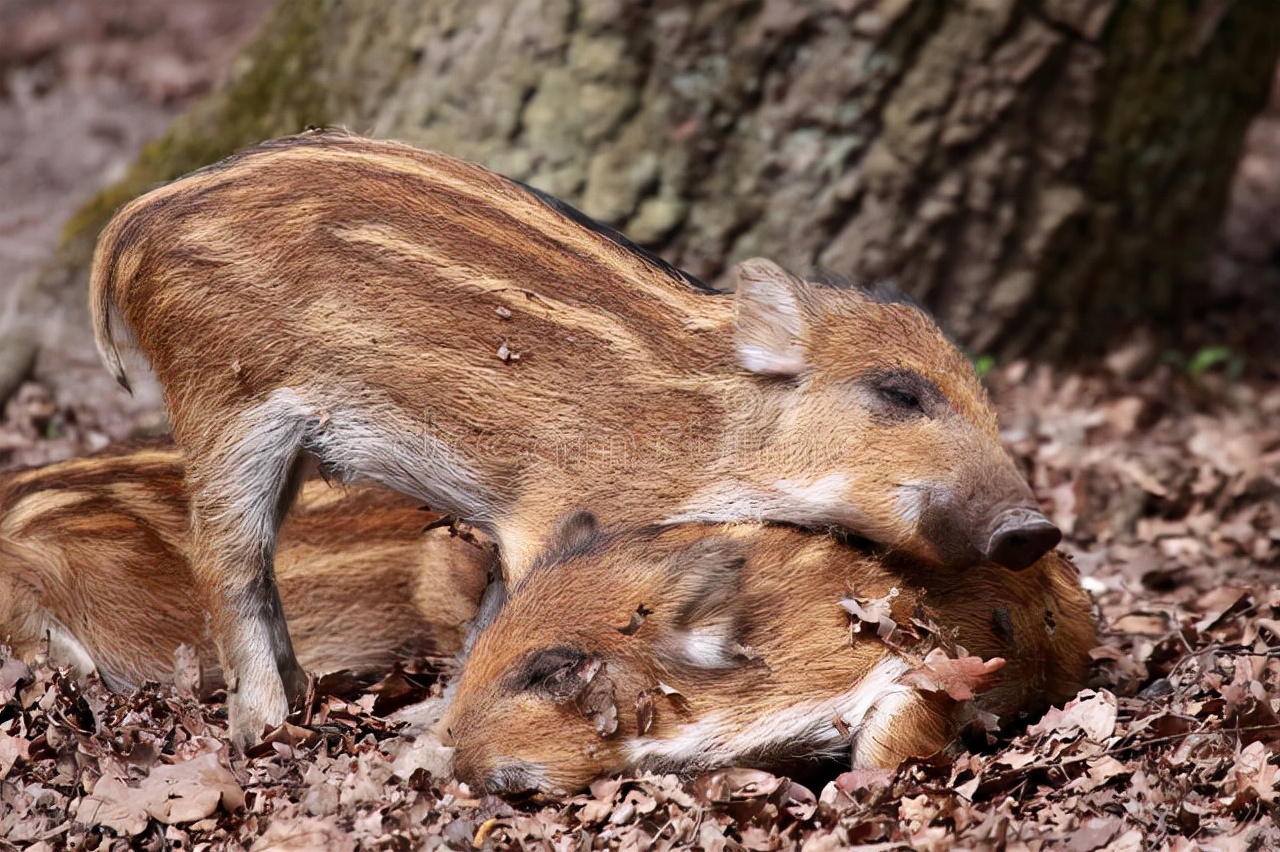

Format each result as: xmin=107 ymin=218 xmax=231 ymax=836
xmin=188 ymin=404 xmax=307 ymax=747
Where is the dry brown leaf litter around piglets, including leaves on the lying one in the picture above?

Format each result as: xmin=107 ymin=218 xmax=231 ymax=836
xmin=0 ymin=355 xmax=1280 ymax=852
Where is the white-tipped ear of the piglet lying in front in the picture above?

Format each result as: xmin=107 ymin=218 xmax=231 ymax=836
xmin=662 ymin=539 xmax=749 ymax=669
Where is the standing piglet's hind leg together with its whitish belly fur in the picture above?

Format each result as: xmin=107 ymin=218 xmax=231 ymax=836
xmin=184 ymin=388 xmax=500 ymax=745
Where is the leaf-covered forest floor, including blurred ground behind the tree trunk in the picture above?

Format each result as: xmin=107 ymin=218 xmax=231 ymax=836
xmin=0 ymin=0 xmax=1280 ymax=852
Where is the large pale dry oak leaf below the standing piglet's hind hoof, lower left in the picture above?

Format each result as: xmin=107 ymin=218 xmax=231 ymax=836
xmin=76 ymin=750 xmax=244 ymax=837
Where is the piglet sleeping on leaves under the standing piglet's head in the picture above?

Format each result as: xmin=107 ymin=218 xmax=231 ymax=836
xmin=442 ymin=516 xmax=1094 ymax=792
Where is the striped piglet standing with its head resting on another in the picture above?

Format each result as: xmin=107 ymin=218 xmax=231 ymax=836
xmin=91 ymin=133 xmax=1059 ymax=743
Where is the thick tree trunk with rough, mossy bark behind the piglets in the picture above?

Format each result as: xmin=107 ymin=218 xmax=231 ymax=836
xmin=12 ymin=0 xmax=1280 ymax=409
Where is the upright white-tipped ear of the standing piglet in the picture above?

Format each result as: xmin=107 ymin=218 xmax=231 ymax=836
xmin=733 ymin=257 xmax=809 ymax=376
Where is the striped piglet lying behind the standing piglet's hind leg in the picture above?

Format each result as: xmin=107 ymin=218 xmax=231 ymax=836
xmin=0 ymin=449 xmax=497 ymax=690
